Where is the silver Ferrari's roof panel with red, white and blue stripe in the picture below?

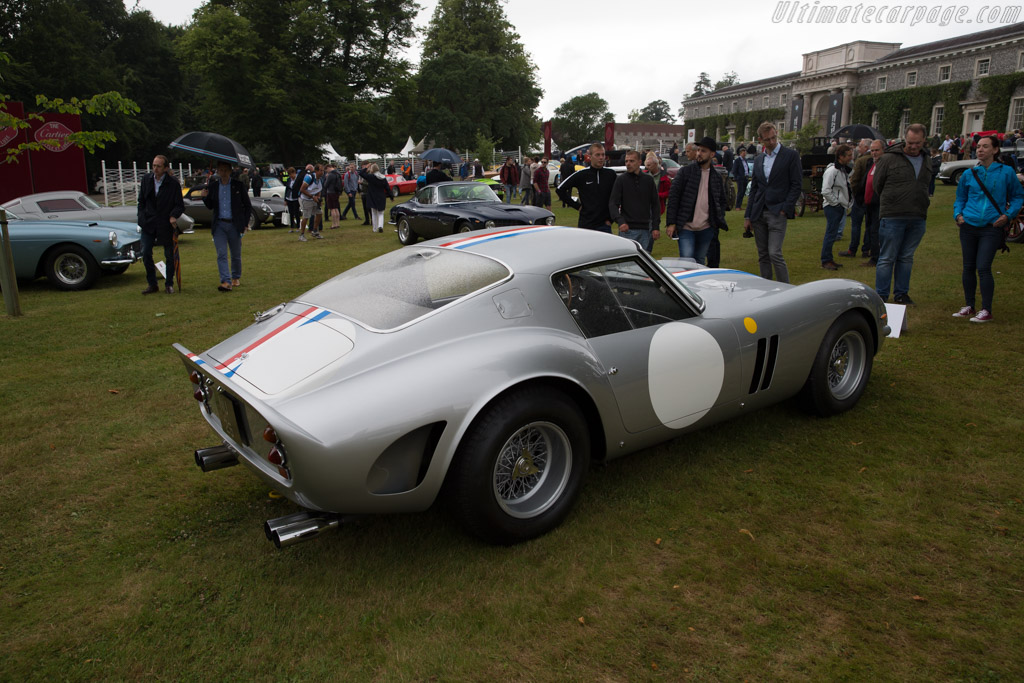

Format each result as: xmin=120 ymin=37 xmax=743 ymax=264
xmin=423 ymin=225 xmax=637 ymax=274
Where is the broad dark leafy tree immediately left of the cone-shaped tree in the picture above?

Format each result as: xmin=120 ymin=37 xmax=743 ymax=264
xmin=176 ymin=0 xmax=417 ymax=163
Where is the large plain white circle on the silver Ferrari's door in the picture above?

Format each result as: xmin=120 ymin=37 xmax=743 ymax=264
xmin=647 ymin=323 xmax=725 ymax=429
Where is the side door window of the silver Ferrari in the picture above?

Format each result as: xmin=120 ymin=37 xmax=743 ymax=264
xmin=552 ymin=259 xmax=693 ymax=337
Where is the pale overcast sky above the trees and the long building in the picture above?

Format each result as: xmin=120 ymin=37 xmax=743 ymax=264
xmin=136 ymin=0 xmax=1024 ymax=122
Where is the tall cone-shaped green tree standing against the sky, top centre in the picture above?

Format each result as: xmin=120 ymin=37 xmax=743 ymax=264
xmin=415 ymin=0 xmax=543 ymax=148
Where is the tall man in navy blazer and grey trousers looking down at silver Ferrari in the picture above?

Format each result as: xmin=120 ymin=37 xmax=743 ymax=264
xmin=743 ymin=121 xmax=803 ymax=283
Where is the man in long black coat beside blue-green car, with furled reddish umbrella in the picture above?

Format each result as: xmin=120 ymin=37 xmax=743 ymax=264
xmin=138 ymin=155 xmax=185 ymax=294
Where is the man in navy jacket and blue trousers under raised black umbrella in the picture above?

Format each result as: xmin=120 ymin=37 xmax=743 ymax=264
xmin=203 ymin=161 xmax=253 ymax=292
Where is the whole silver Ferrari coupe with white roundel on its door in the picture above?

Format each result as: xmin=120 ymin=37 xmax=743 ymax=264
xmin=175 ymin=225 xmax=889 ymax=547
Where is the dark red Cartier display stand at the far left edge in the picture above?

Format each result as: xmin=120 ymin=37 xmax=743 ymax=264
xmin=0 ymin=101 xmax=89 ymax=203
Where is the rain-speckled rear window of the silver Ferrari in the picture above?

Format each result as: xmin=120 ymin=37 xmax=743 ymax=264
xmin=300 ymin=247 xmax=512 ymax=331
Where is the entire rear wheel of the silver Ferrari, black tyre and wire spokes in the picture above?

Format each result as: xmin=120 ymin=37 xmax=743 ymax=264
xmin=445 ymin=389 xmax=591 ymax=545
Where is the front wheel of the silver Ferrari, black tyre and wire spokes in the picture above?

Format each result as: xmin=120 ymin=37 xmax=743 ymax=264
xmin=799 ymin=312 xmax=874 ymax=417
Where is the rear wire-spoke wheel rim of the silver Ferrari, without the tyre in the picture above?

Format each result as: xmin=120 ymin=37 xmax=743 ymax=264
xmin=493 ymin=422 xmax=572 ymax=518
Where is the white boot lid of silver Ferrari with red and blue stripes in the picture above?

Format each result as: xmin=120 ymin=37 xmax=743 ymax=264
xmin=206 ymin=302 xmax=355 ymax=395
